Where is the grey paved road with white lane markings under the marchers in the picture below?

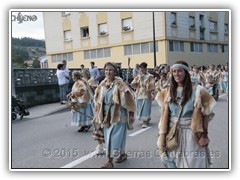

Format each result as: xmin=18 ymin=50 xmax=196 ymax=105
xmin=11 ymin=95 xmax=229 ymax=169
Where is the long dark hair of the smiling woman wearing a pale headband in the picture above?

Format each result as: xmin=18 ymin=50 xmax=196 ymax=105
xmin=170 ymin=61 xmax=192 ymax=105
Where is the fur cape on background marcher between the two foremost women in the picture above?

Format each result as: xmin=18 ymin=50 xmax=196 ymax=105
xmin=131 ymin=73 xmax=155 ymax=101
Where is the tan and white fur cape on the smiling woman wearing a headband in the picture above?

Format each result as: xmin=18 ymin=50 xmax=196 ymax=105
xmin=155 ymin=85 xmax=216 ymax=152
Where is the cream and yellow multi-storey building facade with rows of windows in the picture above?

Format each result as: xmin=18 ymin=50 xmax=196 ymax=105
xmin=43 ymin=10 xmax=230 ymax=68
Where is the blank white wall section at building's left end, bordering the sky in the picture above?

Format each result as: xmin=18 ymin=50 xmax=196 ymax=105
xmin=43 ymin=12 xmax=64 ymax=53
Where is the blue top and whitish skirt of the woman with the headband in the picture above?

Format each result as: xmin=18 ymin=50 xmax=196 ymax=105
xmin=169 ymin=86 xmax=210 ymax=168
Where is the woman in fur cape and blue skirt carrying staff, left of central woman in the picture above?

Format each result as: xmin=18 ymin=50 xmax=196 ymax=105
xmin=67 ymin=70 xmax=94 ymax=132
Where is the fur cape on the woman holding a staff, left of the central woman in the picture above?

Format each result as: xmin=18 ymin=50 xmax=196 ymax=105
xmin=72 ymin=80 xmax=91 ymax=103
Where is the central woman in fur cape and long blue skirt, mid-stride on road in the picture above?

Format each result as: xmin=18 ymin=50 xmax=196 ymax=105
xmin=94 ymin=62 xmax=136 ymax=168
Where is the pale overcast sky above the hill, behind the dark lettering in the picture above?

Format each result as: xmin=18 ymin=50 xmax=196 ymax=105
xmin=11 ymin=11 xmax=45 ymax=39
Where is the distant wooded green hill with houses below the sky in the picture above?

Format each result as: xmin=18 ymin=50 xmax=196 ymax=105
xmin=11 ymin=37 xmax=46 ymax=68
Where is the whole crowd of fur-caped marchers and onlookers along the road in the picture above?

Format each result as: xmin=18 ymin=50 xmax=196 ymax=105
xmin=56 ymin=61 xmax=228 ymax=168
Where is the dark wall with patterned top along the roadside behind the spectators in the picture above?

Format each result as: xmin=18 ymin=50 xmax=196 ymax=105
xmin=11 ymin=69 xmax=142 ymax=107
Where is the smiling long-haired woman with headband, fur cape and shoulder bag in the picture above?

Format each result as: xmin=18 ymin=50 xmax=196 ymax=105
xmin=156 ymin=61 xmax=216 ymax=168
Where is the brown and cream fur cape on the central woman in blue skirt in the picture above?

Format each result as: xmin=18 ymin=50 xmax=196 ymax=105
xmin=94 ymin=77 xmax=136 ymax=124
